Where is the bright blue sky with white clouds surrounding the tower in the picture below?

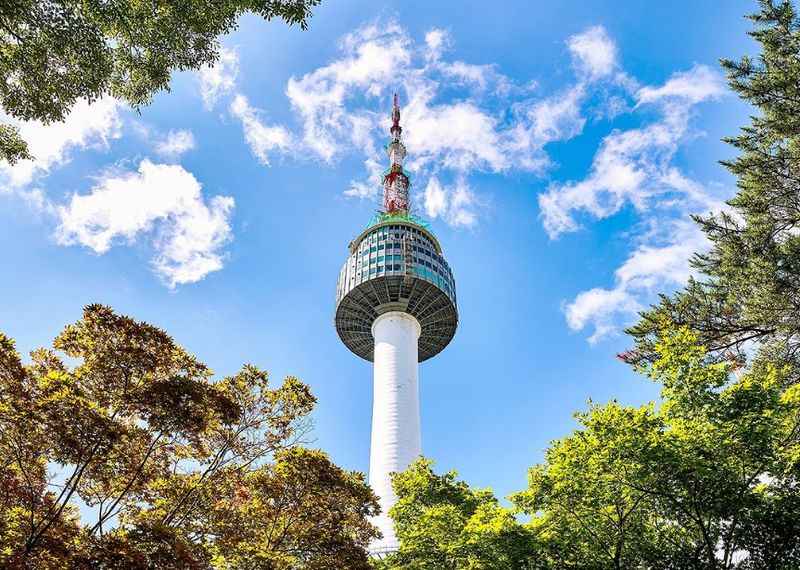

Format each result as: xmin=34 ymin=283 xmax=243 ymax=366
xmin=0 ymin=0 xmax=755 ymax=502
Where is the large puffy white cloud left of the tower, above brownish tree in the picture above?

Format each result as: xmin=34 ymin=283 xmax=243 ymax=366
xmin=56 ymin=160 xmax=234 ymax=288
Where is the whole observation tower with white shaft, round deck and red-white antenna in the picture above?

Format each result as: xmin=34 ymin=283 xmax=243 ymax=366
xmin=336 ymin=95 xmax=458 ymax=553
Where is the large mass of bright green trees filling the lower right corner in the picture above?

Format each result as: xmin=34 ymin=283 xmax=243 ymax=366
xmin=512 ymin=328 xmax=800 ymax=570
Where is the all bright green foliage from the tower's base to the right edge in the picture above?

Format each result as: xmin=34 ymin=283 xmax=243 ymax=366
xmin=378 ymin=327 xmax=800 ymax=570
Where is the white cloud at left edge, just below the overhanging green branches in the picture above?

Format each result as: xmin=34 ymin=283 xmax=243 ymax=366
xmin=0 ymin=97 xmax=122 ymax=187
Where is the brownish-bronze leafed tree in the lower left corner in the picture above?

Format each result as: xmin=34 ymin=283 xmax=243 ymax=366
xmin=0 ymin=305 xmax=378 ymax=569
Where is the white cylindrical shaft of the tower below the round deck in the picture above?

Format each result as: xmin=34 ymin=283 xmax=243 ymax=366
xmin=369 ymin=311 xmax=422 ymax=551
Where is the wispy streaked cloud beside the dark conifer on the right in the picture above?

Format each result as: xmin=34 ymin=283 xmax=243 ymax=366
xmin=552 ymin=65 xmax=725 ymax=343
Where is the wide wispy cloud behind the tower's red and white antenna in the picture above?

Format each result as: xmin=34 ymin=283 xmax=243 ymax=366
xmin=178 ymin=22 xmax=629 ymax=235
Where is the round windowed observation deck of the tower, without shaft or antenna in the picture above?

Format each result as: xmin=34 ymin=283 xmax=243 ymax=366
xmin=336 ymin=213 xmax=458 ymax=362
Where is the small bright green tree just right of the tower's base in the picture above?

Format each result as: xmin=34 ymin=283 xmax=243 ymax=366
xmin=379 ymin=458 xmax=535 ymax=570
